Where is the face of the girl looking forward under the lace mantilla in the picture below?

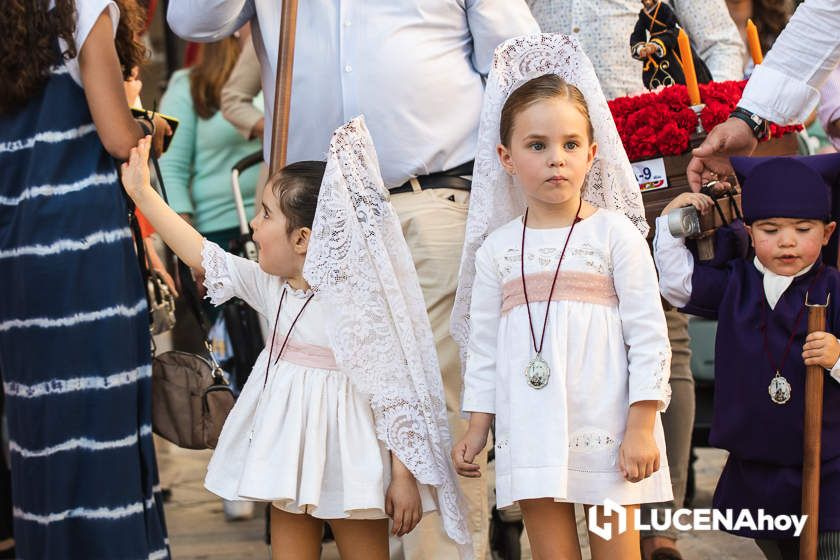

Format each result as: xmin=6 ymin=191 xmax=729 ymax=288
xmin=497 ymin=98 xmax=598 ymax=210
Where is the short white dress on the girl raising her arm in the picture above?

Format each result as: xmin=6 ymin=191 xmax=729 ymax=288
xmin=202 ymin=241 xmax=435 ymax=519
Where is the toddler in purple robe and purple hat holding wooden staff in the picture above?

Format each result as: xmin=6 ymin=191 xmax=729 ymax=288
xmin=654 ymin=154 xmax=840 ymax=559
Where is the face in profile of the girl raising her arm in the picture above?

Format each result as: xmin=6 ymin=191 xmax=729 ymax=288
xmin=251 ymin=185 xmax=310 ymax=278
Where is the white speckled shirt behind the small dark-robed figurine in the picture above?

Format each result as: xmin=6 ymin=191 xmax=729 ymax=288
xmin=526 ymin=0 xmax=745 ymax=99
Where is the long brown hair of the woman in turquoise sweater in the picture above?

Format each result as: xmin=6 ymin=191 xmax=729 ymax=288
xmin=190 ymin=37 xmax=241 ymax=119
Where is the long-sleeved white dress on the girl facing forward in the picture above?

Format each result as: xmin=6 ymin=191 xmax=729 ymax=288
xmin=463 ymin=209 xmax=672 ymax=508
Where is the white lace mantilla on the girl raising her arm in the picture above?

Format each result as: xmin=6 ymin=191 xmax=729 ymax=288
xmin=304 ymin=117 xmax=472 ymax=558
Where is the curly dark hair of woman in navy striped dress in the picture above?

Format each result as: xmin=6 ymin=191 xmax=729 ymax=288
xmin=0 ymin=0 xmax=146 ymax=114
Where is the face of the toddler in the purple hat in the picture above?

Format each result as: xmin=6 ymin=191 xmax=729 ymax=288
xmin=747 ymin=218 xmax=837 ymax=276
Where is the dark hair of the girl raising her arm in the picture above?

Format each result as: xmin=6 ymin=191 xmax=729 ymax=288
xmin=266 ymin=161 xmax=327 ymax=233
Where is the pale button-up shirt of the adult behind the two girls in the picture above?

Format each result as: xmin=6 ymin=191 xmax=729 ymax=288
xmin=167 ymin=0 xmax=539 ymax=187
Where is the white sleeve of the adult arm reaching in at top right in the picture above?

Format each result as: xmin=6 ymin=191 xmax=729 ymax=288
xmin=738 ymin=0 xmax=840 ymax=124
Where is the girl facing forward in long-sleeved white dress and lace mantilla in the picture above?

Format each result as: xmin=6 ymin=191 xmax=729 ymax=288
xmin=453 ymin=35 xmax=671 ymax=559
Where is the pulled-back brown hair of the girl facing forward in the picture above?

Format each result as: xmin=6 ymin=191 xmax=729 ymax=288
xmin=499 ymin=74 xmax=595 ymax=146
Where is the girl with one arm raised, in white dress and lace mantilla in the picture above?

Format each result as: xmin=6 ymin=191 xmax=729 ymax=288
xmin=122 ymin=116 xmax=469 ymax=560
